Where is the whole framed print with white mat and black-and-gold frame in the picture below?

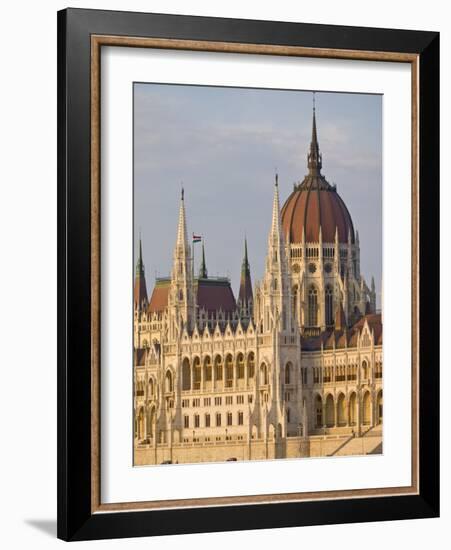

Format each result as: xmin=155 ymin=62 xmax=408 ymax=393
xmin=58 ymin=9 xmax=439 ymax=540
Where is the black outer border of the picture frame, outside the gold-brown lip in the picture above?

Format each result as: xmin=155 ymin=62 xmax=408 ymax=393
xmin=58 ymin=9 xmax=440 ymax=540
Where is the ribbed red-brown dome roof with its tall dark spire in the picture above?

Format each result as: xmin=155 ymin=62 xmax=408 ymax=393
xmin=281 ymin=106 xmax=355 ymax=243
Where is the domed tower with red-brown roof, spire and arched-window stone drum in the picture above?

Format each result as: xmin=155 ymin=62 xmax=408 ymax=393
xmin=282 ymin=97 xmax=375 ymax=336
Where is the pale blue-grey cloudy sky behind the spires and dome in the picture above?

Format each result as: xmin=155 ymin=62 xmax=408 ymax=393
xmin=134 ymin=83 xmax=382 ymax=303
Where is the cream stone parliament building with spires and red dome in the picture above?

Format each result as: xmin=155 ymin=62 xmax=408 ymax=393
xmin=133 ymin=110 xmax=383 ymax=465
